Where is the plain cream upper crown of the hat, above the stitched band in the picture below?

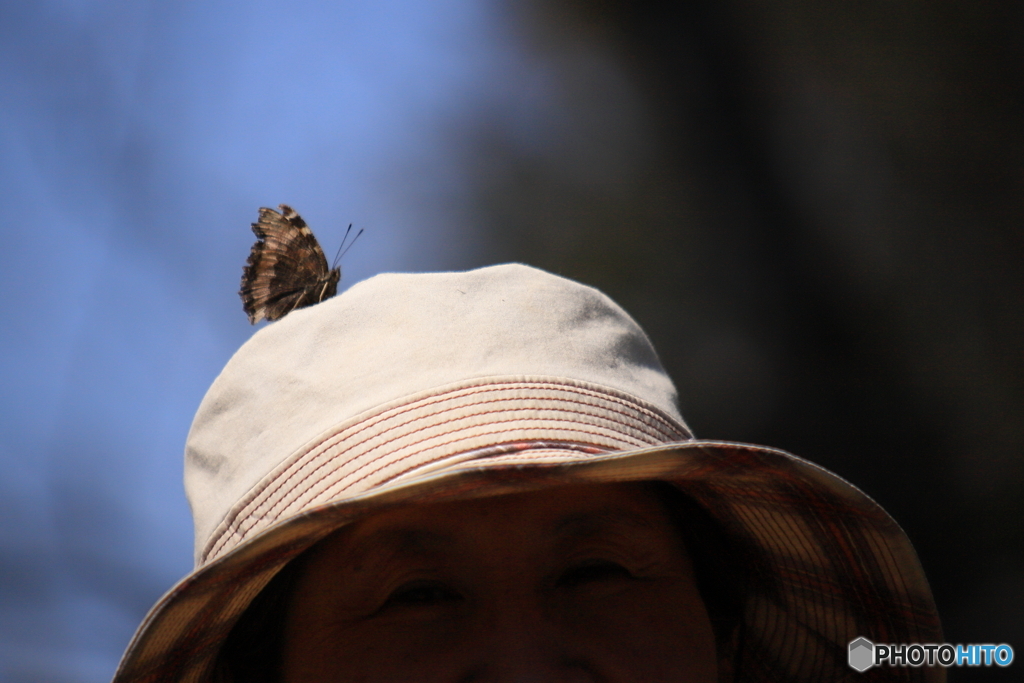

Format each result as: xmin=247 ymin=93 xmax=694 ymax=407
xmin=185 ymin=264 xmax=685 ymax=558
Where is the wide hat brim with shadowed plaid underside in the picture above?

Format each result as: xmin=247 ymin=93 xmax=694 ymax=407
xmin=114 ymin=440 xmax=944 ymax=683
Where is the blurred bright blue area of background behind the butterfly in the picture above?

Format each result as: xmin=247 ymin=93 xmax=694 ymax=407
xmin=0 ymin=0 xmax=543 ymax=682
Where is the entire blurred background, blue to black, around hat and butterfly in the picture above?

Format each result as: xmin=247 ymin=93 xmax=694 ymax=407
xmin=0 ymin=0 xmax=1024 ymax=682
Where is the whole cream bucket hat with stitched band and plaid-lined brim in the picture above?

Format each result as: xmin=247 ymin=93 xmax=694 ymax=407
xmin=114 ymin=264 xmax=944 ymax=683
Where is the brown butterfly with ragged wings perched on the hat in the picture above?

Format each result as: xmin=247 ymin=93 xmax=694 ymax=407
xmin=239 ymin=204 xmax=362 ymax=325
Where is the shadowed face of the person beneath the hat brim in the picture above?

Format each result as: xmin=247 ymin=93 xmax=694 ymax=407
xmin=284 ymin=484 xmax=718 ymax=683
